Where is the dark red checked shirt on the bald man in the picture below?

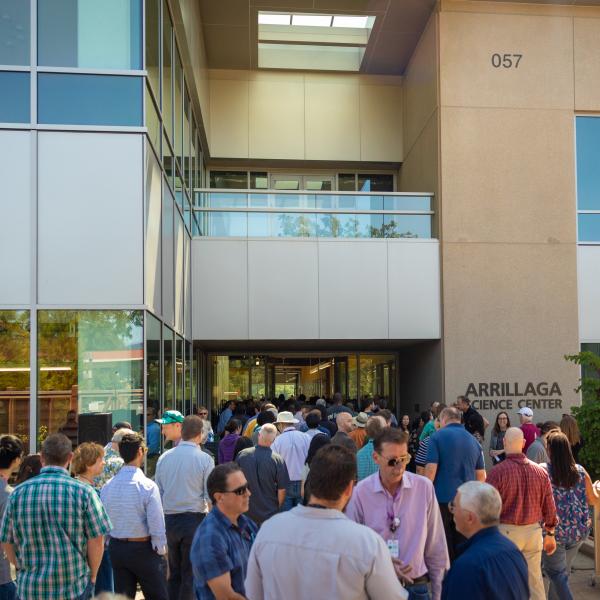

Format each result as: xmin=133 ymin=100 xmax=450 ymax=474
xmin=487 ymin=454 xmax=558 ymax=527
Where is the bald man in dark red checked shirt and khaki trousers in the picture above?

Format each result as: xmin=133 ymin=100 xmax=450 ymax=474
xmin=487 ymin=427 xmax=558 ymax=600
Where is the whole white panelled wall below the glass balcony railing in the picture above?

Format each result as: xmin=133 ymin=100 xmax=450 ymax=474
xmin=192 ymin=239 xmax=440 ymax=340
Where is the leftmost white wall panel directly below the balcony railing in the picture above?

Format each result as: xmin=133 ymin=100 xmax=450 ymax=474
xmin=192 ymin=239 xmax=248 ymax=340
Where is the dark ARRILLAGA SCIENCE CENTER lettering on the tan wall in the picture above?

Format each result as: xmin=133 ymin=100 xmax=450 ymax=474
xmin=465 ymin=381 xmax=562 ymax=410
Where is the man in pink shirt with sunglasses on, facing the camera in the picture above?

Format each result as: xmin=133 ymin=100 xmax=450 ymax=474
xmin=346 ymin=428 xmax=450 ymax=600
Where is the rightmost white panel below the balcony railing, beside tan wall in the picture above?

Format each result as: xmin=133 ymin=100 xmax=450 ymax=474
xmin=387 ymin=240 xmax=441 ymax=340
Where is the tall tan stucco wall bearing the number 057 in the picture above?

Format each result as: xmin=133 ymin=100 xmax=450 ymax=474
xmin=439 ymin=2 xmax=584 ymax=423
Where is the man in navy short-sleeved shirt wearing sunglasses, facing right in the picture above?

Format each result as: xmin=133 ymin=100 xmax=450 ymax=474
xmin=190 ymin=462 xmax=258 ymax=600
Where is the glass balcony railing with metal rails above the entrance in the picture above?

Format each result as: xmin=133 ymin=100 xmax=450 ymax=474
xmin=192 ymin=189 xmax=434 ymax=239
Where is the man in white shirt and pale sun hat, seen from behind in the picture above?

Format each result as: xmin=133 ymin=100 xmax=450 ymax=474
xmin=271 ymin=410 xmax=310 ymax=511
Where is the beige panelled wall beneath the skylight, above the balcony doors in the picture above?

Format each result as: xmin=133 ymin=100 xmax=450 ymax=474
xmin=209 ymin=70 xmax=403 ymax=162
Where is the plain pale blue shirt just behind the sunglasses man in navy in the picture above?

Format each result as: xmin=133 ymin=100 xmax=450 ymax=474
xmin=154 ymin=440 xmax=215 ymax=515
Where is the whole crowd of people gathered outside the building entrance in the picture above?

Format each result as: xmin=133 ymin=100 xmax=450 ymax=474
xmin=0 ymin=394 xmax=600 ymax=600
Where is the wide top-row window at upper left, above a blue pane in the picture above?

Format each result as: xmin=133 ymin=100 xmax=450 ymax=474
xmin=38 ymin=0 xmax=142 ymax=69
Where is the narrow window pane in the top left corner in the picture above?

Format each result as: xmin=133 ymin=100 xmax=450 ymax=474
xmin=0 ymin=0 xmax=31 ymax=65
